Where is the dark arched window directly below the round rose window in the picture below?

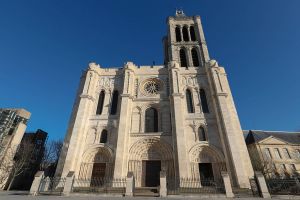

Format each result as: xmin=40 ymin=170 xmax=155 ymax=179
xmin=145 ymin=108 xmax=158 ymax=133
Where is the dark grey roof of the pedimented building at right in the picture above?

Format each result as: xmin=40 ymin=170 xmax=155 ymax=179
xmin=243 ymin=130 xmax=300 ymax=144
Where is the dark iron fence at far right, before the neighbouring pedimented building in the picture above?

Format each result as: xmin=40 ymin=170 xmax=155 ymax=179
xmin=266 ymin=178 xmax=300 ymax=195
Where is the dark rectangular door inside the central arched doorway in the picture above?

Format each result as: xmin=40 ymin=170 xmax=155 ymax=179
xmin=143 ymin=160 xmax=161 ymax=187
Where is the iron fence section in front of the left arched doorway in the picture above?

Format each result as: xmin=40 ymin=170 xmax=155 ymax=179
xmin=72 ymin=178 xmax=126 ymax=194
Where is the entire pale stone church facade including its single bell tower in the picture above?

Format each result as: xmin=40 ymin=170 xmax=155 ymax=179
xmin=56 ymin=11 xmax=253 ymax=188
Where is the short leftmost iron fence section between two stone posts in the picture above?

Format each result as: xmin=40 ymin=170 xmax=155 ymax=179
xmin=39 ymin=177 xmax=66 ymax=195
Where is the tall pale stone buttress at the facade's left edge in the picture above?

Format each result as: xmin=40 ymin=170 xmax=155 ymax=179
xmin=55 ymin=63 xmax=101 ymax=177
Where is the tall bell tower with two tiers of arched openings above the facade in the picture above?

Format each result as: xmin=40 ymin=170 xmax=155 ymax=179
xmin=164 ymin=10 xmax=209 ymax=69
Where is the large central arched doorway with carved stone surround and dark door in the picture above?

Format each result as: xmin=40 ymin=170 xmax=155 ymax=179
xmin=128 ymin=138 xmax=175 ymax=187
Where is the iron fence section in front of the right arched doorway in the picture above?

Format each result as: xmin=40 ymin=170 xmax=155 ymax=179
xmin=168 ymin=178 xmax=225 ymax=195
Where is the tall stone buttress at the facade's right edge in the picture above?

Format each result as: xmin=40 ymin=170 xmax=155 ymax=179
xmin=205 ymin=60 xmax=254 ymax=188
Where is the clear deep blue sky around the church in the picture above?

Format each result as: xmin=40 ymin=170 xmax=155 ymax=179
xmin=0 ymin=0 xmax=300 ymax=139
